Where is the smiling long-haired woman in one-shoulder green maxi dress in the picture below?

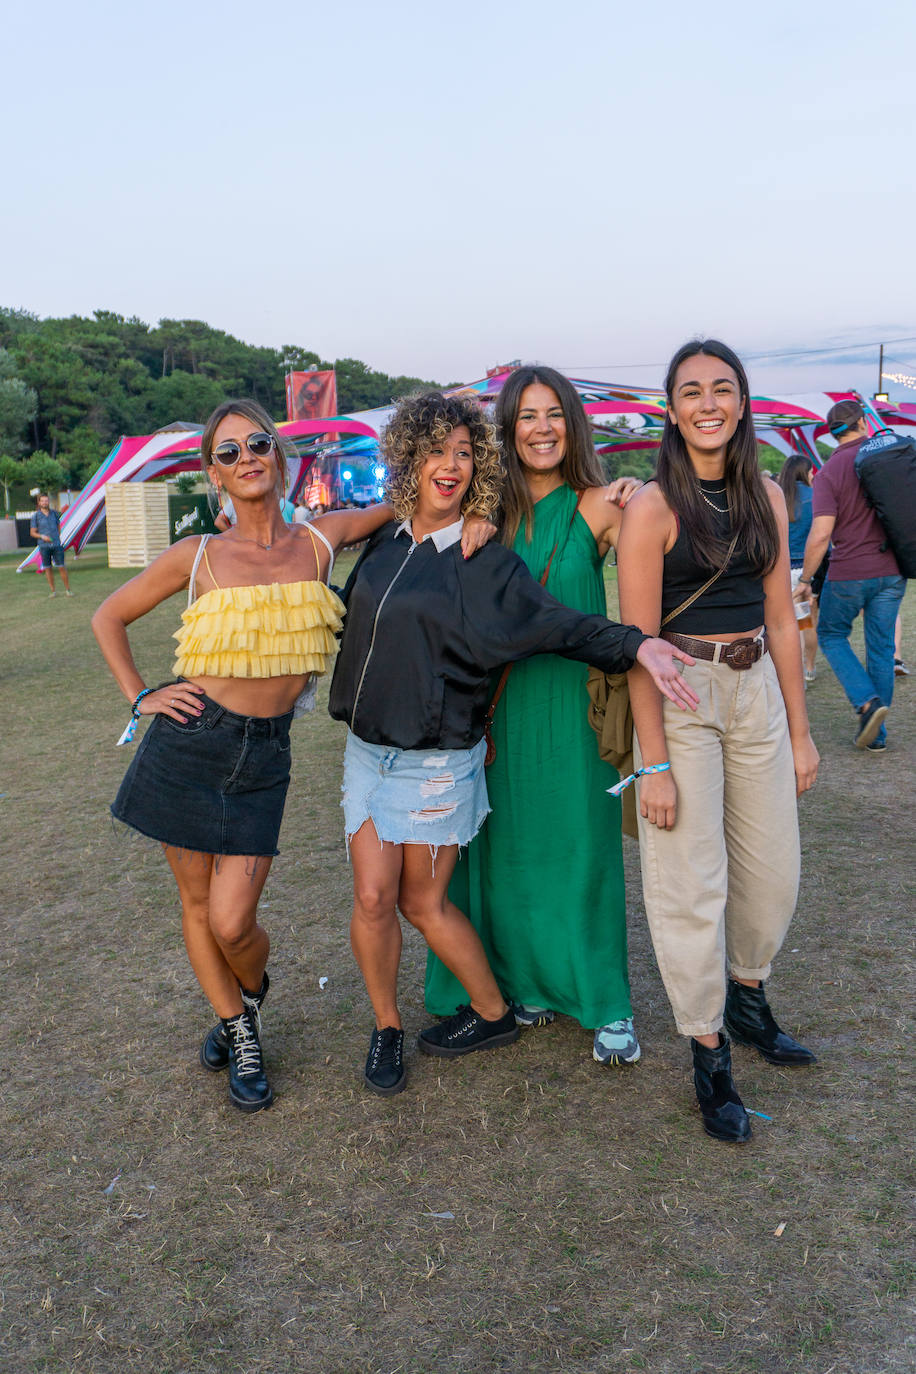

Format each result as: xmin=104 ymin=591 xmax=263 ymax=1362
xmin=426 ymin=367 xmax=640 ymax=1063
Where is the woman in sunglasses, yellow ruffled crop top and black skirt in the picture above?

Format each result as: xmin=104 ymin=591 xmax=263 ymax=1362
xmin=92 ymin=401 xmax=486 ymax=1112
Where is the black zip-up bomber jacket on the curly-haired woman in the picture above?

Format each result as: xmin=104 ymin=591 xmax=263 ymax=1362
xmin=328 ymin=521 xmax=648 ymax=749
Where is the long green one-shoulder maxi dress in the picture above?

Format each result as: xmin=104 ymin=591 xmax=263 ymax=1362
xmin=426 ymin=486 xmax=632 ymax=1029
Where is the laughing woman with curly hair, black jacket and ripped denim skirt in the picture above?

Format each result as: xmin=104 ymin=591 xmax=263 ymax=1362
xmin=330 ymin=392 xmax=695 ymax=1095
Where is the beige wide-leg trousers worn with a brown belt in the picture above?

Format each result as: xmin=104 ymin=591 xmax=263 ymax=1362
xmin=634 ymin=654 xmax=801 ymax=1036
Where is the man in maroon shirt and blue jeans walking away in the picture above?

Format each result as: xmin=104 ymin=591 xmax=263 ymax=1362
xmin=795 ymin=401 xmax=906 ymax=752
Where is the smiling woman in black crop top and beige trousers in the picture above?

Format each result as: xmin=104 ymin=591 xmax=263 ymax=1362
xmin=618 ymin=339 xmax=818 ymax=1140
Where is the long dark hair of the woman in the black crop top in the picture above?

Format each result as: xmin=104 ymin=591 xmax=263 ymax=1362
xmin=655 ymin=339 xmax=779 ymax=576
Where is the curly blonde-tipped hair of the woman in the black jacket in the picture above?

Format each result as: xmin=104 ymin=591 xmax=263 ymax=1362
xmin=382 ymin=392 xmax=505 ymax=519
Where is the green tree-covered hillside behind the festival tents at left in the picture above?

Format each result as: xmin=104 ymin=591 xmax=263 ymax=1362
xmin=0 ymin=308 xmax=439 ymax=488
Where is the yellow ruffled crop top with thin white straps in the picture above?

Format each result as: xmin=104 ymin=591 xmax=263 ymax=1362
xmin=172 ymin=525 xmax=345 ymax=677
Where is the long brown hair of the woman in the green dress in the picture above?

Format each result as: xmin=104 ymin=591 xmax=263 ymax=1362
xmin=496 ymin=363 xmax=604 ymax=545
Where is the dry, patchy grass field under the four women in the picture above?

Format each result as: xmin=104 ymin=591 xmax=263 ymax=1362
xmin=0 ymin=548 xmax=916 ymax=1374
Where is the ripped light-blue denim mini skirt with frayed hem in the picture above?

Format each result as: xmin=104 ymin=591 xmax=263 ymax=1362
xmin=341 ymin=731 xmax=490 ymax=853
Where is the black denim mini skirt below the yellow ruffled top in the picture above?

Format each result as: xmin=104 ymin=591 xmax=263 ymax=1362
xmin=111 ymin=697 xmax=293 ymax=856
